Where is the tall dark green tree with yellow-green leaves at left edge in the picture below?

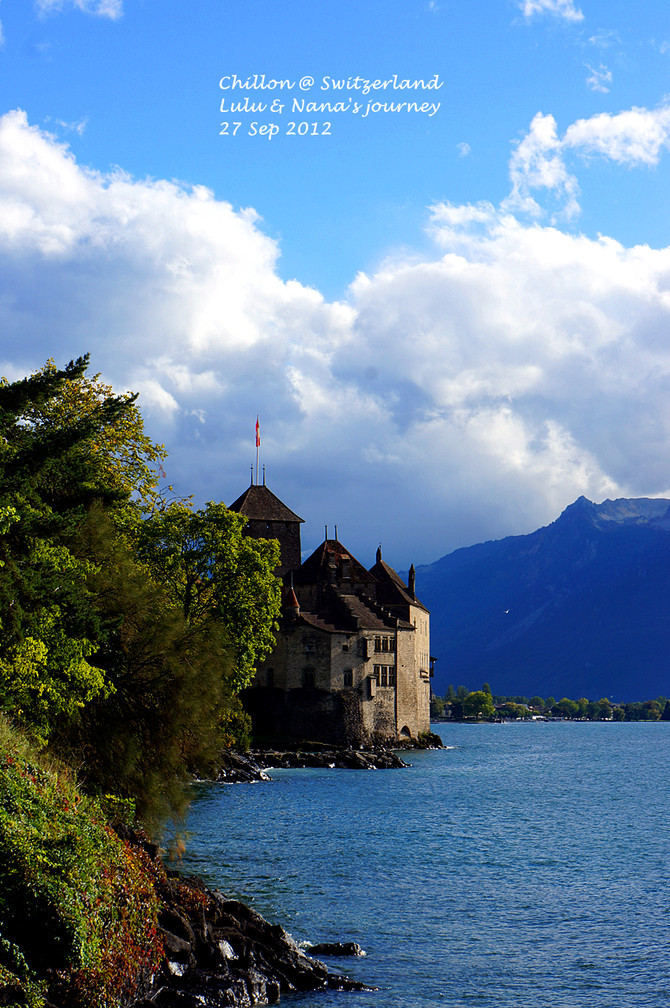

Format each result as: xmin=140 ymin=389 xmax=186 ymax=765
xmin=0 ymin=358 xmax=140 ymax=741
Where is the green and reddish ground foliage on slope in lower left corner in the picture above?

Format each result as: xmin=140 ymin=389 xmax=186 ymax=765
xmin=0 ymin=720 xmax=162 ymax=1008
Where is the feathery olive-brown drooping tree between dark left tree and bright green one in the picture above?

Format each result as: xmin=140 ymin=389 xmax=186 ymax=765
xmin=52 ymin=511 xmax=233 ymax=828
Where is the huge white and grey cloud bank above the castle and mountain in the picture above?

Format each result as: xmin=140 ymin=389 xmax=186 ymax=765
xmin=0 ymin=112 xmax=670 ymax=566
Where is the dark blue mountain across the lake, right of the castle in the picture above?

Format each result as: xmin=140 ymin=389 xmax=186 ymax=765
xmin=416 ymin=497 xmax=670 ymax=701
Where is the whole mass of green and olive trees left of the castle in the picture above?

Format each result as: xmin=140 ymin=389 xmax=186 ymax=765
xmin=0 ymin=357 xmax=279 ymax=824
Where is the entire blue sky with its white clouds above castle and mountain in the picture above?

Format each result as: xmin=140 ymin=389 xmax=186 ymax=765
xmin=0 ymin=0 xmax=670 ymax=570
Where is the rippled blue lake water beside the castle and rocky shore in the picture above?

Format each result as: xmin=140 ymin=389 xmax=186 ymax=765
xmin=183 ymin=723 xmax=670 ymax=1008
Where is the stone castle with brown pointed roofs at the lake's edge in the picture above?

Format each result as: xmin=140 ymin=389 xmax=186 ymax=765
xmin=230 ymin=478 xmax=431 ymax=745
